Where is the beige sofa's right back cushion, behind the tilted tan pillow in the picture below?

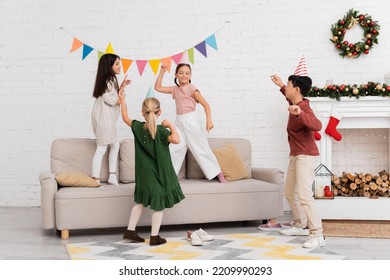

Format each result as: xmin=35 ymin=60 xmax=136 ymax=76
xmin=187 ymin=138 xmax=252 ymax=179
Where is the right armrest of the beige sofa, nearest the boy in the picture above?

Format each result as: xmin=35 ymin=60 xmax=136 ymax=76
xmin=252 ymin=167 xmax=284 ymax=218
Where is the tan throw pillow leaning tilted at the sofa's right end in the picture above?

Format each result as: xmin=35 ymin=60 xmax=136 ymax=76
xmin=213 ymin=144 xmax=249 ymax=182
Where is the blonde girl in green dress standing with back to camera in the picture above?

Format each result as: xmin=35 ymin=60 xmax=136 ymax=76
xmin=120 ymin=93 xmax=184 ymax=246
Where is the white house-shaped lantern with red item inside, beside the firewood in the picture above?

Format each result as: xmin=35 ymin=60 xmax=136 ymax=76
xmin=313 ymin=163 xmax=334 ymax=199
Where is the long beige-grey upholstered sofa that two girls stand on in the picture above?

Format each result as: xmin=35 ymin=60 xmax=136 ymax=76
xmin=39 ymin=138 xmax=284 ymax=239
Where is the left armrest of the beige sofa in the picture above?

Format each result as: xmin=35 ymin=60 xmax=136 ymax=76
xmin=39 ymin=170 xmax=58 ymax=229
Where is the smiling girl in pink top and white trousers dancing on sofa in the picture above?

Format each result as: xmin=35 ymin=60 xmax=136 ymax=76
xmin=154 ymin=63 xmax=227 ymax=183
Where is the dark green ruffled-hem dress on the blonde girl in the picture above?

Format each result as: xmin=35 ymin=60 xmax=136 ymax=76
xmin=131 ymin=120 xmax=184 ymax=211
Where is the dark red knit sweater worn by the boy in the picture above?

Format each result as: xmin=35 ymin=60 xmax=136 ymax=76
xmin=280 ymin=86 xmax=322 ymax=156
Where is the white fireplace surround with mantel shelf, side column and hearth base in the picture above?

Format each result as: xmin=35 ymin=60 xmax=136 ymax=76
xmin=308 ymin=96 xmax=390 ymax=220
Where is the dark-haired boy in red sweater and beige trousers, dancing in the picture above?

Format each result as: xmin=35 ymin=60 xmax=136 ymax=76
xmin=271 ymin=75 xmax=326 ymax=248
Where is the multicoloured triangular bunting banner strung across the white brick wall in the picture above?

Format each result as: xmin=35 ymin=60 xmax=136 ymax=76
xmin=60 ymin=21 xmax=229 ymax=76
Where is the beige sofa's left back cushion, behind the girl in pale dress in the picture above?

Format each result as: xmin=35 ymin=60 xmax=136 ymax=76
xmin=50 ymin=138 xmax=109 ymax=183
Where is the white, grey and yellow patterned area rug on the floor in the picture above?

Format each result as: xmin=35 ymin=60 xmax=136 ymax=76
xmin=66 ymin=232 xmax=345 ymax=260
